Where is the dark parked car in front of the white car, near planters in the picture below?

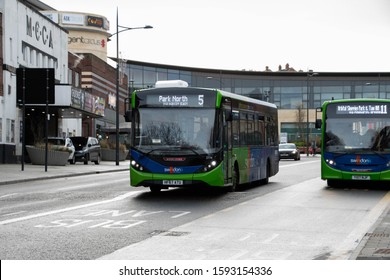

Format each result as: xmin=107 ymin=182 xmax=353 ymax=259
xmin=70 ymin=136 xmax=102 ymax=164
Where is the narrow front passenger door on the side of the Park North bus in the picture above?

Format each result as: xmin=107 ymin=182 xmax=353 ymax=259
xmin=223 ymin=100 xmax=233 ymax=185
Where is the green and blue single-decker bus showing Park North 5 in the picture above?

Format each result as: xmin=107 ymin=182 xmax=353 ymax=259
xmin=126 ymin=81 xmax=279 ymax=192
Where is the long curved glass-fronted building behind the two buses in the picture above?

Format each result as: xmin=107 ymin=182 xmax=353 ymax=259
xmin=125 ymin=60 xmax=390 ymax=144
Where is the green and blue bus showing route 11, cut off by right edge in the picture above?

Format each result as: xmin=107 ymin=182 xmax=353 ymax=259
xmin=316 ymin=99 xmax=390 ymax=186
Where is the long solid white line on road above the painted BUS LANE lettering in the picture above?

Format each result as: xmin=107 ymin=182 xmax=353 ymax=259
xmin=0 ymin=191 xmax=142 ymax=225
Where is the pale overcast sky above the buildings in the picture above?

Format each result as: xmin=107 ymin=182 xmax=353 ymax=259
xmin=41 ymin=0 xmax=390 ymax=72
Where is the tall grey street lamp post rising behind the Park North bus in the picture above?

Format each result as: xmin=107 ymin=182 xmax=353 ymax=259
xmin=109 ymin=8 xmax=153 ymax=165
